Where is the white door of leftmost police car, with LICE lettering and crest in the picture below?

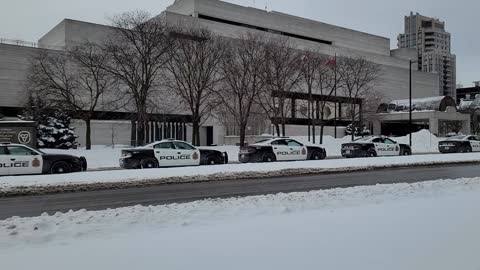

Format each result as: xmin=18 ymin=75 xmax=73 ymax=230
xmin=7 ymin=145 xmax=43 ymax=175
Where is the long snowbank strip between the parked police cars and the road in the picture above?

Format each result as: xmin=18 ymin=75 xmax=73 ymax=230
xmin=0 ymin=153 xmax=480 ymax=195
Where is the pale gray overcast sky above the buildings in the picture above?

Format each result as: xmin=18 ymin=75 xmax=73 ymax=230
xmin=0 ymin=0 xmax=480 ymax=86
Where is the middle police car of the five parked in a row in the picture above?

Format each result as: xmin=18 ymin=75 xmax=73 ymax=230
xmin=238 ymin=138 xmax=327 ymax=163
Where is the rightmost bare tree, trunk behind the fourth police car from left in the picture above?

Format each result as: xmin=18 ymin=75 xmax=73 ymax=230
xmin=337 ymin=57 xmax=380 ymax=140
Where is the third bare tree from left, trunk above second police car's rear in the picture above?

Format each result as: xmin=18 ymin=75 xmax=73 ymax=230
xmin=165 ymin=27 xmax=225 ymax=145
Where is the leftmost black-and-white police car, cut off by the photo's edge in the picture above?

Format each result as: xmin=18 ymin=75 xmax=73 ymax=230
xmin=0 ymin=143 xmax=87 ymax=176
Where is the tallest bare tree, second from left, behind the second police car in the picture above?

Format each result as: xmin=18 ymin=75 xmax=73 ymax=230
xmin=105 ymin=11 xmax=174 ymax=145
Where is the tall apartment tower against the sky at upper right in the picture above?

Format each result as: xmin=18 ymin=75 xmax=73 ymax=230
xmin=398 ymin=12 xmax=457 ymax=98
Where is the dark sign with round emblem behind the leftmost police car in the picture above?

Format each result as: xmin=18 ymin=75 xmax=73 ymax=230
xmin=0 ymin=121 xmax=37 ymax=148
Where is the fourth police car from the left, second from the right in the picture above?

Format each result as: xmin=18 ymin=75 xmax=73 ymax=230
xmin=342 ymin=136 xmax=412 ymax=158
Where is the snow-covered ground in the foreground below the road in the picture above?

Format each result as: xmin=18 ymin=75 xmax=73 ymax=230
xmin=0 ymin=178 xmax=480 ymax=270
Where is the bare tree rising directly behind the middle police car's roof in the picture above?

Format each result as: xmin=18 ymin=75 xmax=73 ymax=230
xmin=260 ymin=38 xmax=301 ymax=136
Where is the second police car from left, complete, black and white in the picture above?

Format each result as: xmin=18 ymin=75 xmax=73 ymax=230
xmin=120 ymin=139 xmax=228 ymax=169
